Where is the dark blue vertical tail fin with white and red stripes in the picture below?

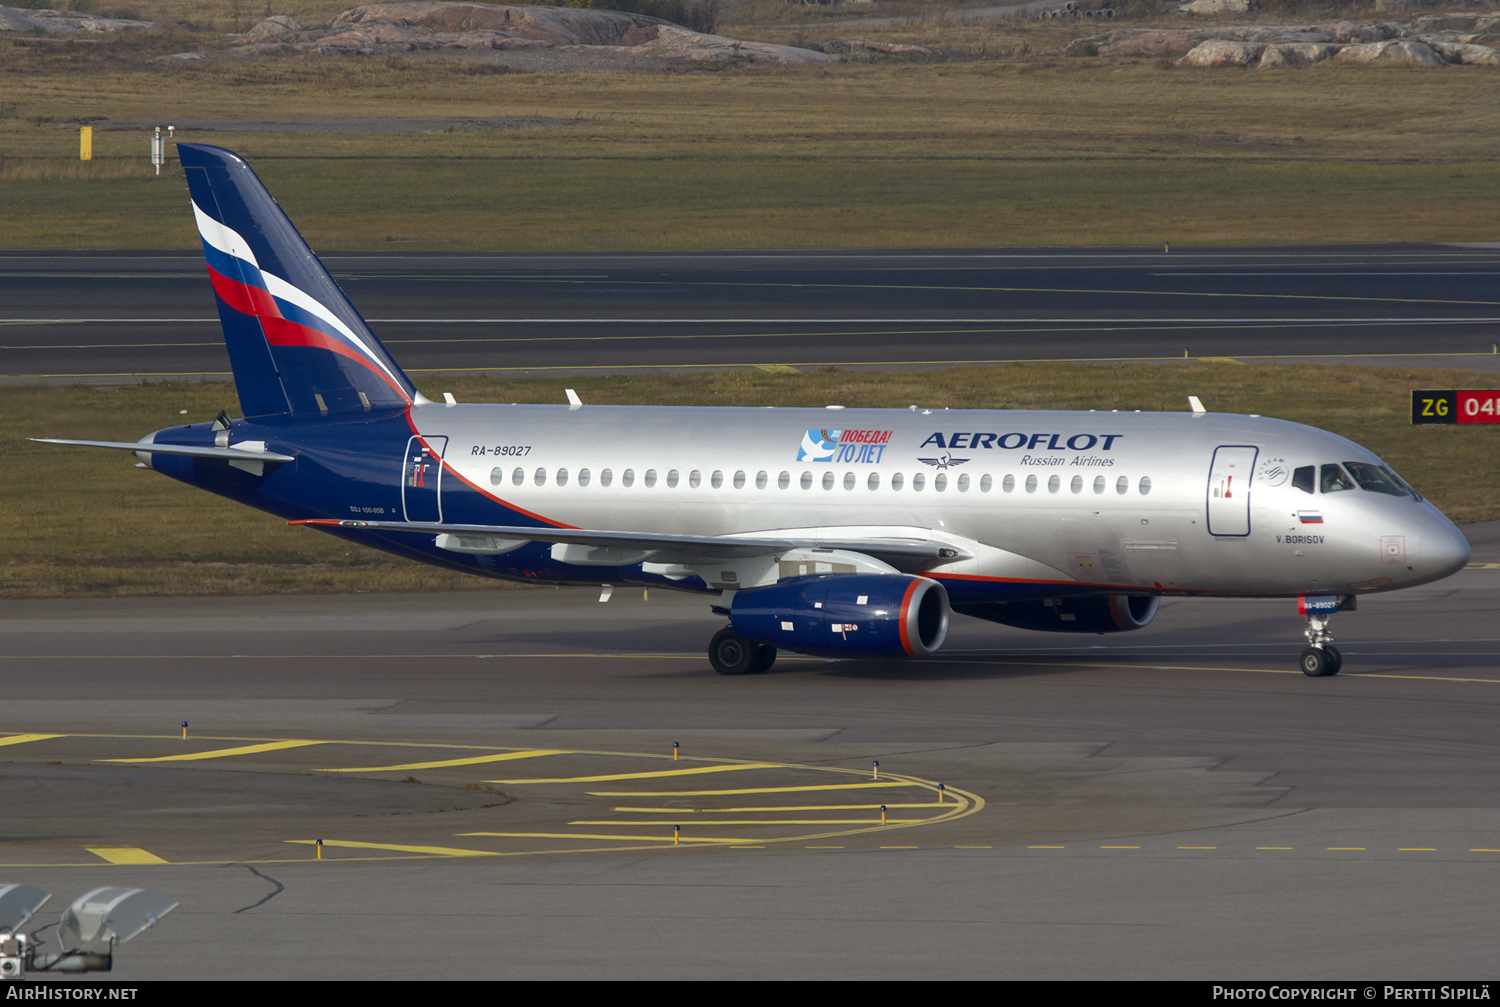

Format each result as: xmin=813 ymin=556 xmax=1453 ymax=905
xmin=177 ymin=144 xmax=419 ymax=416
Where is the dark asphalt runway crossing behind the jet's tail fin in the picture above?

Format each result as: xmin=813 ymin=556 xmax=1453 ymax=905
xmin=0 ymin=246 xmax=1500 ymax=383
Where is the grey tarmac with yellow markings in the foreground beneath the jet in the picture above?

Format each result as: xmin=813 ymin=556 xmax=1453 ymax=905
xmin=0 ymin=525 xmax=1500 ymax=981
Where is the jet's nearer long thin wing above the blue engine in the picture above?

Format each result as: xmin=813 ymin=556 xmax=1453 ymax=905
xmin=290 ymin=518 xmax=971 ymax=570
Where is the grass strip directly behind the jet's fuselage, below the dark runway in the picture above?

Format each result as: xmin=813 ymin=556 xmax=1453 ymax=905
xmin=0 ymin=362 xmax=1500 ymax=599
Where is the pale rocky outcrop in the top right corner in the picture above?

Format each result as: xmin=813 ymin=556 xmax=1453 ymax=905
xmin=1047 ymin=15 xmax=1500 ymax=69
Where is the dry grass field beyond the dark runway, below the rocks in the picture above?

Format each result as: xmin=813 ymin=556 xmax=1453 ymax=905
xmin=0 ymin=42 xmax=1500 ymax=251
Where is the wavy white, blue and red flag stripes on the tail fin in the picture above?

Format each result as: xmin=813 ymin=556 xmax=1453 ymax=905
xmin=192 ymin=203 xmax=408 ymax=399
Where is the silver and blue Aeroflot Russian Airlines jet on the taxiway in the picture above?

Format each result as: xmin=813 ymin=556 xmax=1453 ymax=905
xmin=35 ymin=144 xmax=1469 ymax=677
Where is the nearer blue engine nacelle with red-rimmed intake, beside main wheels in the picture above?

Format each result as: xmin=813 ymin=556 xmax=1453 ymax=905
xmin=729 ymin=573 xmax=951 ymax=657
